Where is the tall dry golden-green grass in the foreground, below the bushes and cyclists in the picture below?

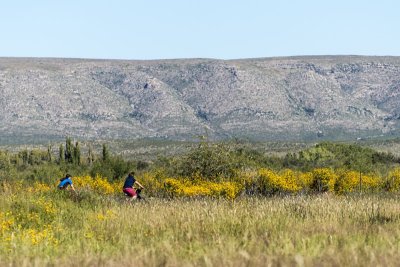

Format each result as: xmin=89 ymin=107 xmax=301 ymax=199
xmin=0 ymin=182 xmax=400 ymax=266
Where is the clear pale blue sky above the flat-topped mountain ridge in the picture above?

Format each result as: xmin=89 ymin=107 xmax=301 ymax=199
xmin=0 ymin=0 xmax=400 ymax=59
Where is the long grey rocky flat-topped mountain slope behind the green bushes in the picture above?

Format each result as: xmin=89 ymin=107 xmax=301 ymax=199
xmin=0 ymin=56 xmax=400 ymax=141
